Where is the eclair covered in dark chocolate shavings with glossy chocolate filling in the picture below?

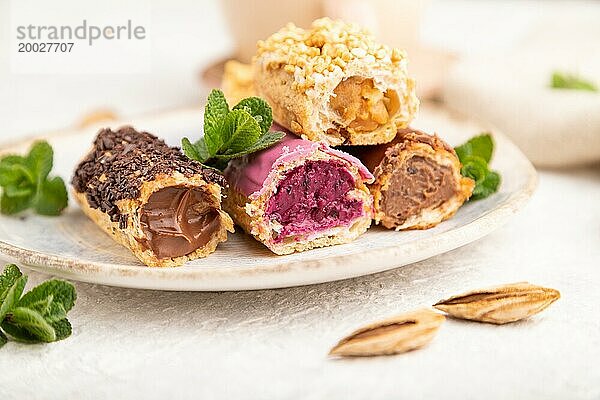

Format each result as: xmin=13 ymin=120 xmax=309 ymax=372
xmin=71 ymin=127 xmax=233 ymax=267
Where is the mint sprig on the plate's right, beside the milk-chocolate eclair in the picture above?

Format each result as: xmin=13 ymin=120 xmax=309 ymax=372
xmin=454 ymin=133 xmax=501 ymax=200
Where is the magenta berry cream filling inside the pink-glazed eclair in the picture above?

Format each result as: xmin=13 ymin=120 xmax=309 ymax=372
xmin=266 ymin=160 xmax=363 ymax=242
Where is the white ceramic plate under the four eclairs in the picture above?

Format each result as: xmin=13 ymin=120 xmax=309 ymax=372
xmin=0 ymin=106 xmax=536 ymax=290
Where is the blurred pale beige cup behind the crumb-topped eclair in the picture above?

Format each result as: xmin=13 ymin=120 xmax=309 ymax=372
xmin=221 ymin=0 xmax=452 ymax=98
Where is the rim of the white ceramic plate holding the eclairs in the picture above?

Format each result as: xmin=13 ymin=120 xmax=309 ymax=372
xmin=0 ymin=104 xmax=538 ymax=291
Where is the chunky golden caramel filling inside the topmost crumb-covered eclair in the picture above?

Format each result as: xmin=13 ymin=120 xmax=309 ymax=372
xmin=329 ymin=76 xmax=400 ymax=132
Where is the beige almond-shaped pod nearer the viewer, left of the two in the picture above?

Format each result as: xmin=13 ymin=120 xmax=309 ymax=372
xmin=329 ymin=309 xmax=445 ymax=357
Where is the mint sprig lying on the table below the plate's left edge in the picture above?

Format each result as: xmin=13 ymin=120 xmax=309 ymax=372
xmin=0 ymin=264 xmax=77 ymax=348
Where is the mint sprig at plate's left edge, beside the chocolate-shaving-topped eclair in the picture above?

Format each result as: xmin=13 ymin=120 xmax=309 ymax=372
xmin=0 ymin=141 xmax=68 ymax=215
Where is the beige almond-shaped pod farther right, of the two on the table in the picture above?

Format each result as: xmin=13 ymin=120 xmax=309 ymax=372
xmin=434 ymin=282 xmax=560 ymax=324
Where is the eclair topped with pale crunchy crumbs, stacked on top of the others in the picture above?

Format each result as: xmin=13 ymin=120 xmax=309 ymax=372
xmin=253 ymin=18 xmax=419 ymax=146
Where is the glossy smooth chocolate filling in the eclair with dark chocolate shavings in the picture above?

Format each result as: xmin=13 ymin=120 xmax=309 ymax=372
xmin=140 ymin=186 xmax=221 ymax=258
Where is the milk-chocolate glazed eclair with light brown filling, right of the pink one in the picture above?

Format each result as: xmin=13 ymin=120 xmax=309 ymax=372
xmin=346 ymin=129 xmax=474 ymax=230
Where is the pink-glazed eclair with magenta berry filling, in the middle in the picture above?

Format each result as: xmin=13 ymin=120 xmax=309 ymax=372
xmin=223 ymin=126 xmax=374 ymax=255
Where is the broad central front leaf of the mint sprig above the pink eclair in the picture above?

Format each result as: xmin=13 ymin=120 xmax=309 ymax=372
xmin=219 ymin=110 xmax=261 ymax=154
